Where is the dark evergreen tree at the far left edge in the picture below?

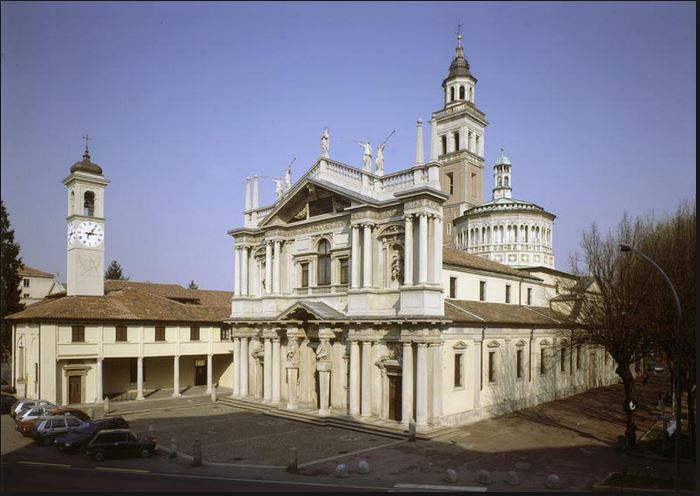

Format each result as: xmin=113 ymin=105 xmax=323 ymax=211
xmin=0 ymin=200 xmax=24 ymax=355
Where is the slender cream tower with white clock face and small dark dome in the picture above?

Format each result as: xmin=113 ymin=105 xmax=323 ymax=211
xmin=63 ymin=137 xmax=109 ymax=296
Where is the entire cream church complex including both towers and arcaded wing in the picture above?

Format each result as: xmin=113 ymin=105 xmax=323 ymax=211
xmin=10 ymin=37 xmax=616 ymax=426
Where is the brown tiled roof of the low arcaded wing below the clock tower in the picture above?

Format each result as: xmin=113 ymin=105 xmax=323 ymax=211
xmin=8 ymin=281 xmax=233 ymax=323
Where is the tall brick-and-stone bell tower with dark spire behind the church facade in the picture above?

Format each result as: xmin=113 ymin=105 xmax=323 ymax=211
xmin=430 ymin=30 xmax=488 ymax=243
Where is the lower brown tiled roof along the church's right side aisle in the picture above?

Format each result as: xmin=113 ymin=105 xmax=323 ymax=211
xmin=445 ymin=299 xmax=574 ymax=327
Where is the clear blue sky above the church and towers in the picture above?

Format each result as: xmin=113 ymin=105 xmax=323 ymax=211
xmin=0 ymin=1 xmax=696 ymax=290
